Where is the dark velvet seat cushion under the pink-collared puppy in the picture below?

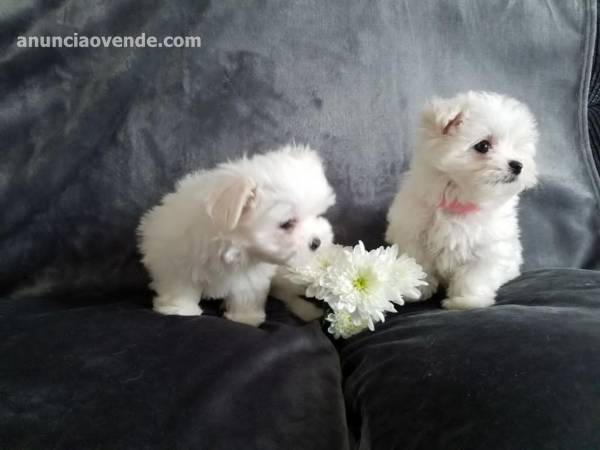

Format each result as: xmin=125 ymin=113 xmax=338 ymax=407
xmin=341 ymin=270 xmax=600 ymax=450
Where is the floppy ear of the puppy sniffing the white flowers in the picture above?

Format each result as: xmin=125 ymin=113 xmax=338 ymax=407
xmin=206 ymin=174 xmax=256 ymax=231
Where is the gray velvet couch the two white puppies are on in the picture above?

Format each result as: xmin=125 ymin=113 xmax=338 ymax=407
xmin=0 ymin=0 xmax=600 ymax=450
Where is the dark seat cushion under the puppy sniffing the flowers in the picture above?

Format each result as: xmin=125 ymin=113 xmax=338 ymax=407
xmin=0 ymin=298 xmax=348 ymax=450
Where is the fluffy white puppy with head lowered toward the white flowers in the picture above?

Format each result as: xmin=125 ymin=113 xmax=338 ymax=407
xmin=138 ymin=145 xmax=335 ymax=326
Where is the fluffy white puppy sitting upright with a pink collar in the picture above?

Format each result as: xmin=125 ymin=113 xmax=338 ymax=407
xmin=386 ymin=92 xmax=537 ymax=309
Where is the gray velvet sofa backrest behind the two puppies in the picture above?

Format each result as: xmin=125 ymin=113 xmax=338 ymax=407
xmin=0 ymin=0 xmax=600 ymax=294
